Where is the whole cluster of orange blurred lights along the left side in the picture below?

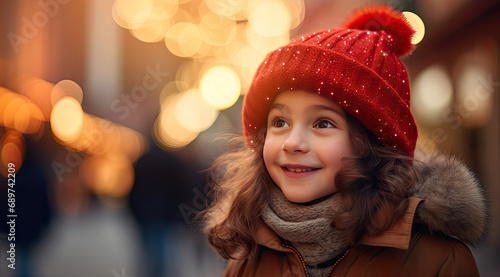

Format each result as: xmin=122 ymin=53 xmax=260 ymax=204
xmin=0 ymin=77 xmax=147 ymax=198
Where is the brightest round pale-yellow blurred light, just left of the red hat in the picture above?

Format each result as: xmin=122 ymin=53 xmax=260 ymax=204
xmin=200 ymin=65 xmax=241 ymax=110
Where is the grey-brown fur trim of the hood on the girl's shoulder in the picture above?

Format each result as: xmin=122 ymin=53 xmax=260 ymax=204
xmin=411 ymin=151 xmax=489 ymax=246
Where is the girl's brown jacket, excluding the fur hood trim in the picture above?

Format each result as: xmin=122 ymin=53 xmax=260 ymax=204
xmin=224 ymin=198 xmax=479 ymax=277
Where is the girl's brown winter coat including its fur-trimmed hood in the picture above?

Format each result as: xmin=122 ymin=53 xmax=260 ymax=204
xmin=224 ymin=151 xmax=488 ymax=277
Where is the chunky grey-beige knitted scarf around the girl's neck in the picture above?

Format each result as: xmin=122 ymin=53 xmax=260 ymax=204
xmin=262 ymin=188 xmax=349 ymax=276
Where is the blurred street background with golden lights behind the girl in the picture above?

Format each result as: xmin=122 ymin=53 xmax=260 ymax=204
xmin=0 ymin=0 xmax=500 ymax=277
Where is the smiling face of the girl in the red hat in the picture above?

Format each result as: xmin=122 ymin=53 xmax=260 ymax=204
xmin=263 ymin=90 xmax=353 ymax=203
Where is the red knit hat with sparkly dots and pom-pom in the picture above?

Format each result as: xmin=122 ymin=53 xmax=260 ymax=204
xmin=242 ymin=5 xmax=417 ymax=157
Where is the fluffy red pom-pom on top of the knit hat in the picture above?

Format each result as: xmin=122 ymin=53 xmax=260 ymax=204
xmin=343 ymin=5 xmax=415 ymax=57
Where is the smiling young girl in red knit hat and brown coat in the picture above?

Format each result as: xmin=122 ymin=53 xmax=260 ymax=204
xmin=201 ymin=6 xmax=487 ymax=276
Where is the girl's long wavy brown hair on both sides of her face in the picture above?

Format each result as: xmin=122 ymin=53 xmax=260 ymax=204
xmin=201 ymin=114 xmax=416 ymax=259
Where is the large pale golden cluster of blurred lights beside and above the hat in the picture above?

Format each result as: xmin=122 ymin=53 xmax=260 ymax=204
xmin=112 ymin=0 xmax=305 ymax=149
